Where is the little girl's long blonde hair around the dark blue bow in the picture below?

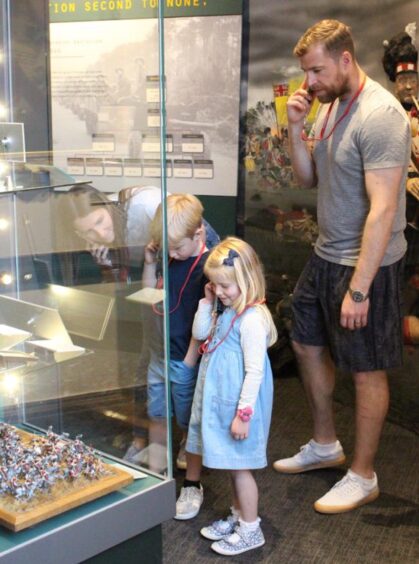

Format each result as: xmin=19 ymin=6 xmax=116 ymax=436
xmin=204 ymin=237 xmax=278 ymax=346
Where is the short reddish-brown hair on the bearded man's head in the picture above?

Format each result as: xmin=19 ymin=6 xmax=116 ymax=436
xmin=294 ymin=20 xmax=355 ymax=58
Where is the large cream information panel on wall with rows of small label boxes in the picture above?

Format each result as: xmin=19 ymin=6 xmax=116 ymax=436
xmin=50 ymin=0 xmax=241 ymax=196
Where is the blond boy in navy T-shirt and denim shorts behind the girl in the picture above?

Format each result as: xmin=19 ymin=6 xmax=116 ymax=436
xmin=143 ymin=194 xmax=208 ymax=519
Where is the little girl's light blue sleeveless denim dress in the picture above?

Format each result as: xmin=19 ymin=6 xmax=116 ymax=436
xmin=186 ymin=307 xmax=273 ymax=470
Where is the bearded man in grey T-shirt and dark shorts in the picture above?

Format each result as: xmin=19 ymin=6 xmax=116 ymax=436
xmin=274 ymin=20 xmax=410 ymax=513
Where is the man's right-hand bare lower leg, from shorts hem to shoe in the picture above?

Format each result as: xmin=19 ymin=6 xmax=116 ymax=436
xmin=351 ymin=370 xmax=389 ymax=478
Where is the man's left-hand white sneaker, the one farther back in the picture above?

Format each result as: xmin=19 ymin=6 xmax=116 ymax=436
xmin=273 ymin=439 xmax=346 ymax=474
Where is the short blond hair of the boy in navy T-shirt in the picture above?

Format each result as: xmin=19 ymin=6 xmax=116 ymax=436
xmin=150 ymin=194 xmax=204 ymax=245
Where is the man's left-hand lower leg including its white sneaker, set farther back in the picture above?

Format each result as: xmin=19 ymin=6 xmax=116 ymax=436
xmin=274 ymin=342 xmax=345 ymax=474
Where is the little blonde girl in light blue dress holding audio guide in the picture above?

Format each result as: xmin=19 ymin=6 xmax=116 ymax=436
xmin=186 ymin=237 xmax=277 ymax=555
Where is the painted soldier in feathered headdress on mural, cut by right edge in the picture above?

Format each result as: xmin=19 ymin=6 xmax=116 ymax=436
xmin=383 ymin=24 xmax=419 ymax=344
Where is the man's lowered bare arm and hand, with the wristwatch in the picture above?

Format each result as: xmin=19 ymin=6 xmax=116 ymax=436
xmin=341 ymin=167 xmax=404 ymax=329
